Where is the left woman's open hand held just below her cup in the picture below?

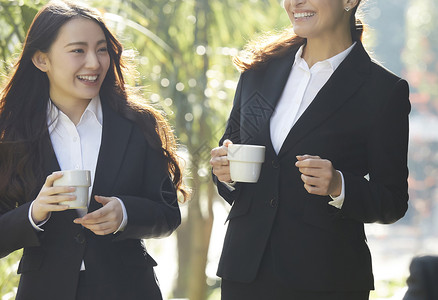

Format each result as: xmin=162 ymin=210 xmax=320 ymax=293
xmin=74 ymin=196 xmax=123 ymax=235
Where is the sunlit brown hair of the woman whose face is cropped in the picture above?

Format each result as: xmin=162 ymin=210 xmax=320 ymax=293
xmin=233 ymin=0 xmax=365 ymax=72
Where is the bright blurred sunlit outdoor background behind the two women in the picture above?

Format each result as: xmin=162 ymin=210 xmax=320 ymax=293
xmin=0 ymin=0 xmax=438 ymax=300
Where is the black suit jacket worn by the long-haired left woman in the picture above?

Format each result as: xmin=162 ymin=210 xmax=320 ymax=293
xmin=0 ymin=99 xmax=181 ymax=300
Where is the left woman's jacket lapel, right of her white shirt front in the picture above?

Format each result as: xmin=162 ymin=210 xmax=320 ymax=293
xmin=88 ymin=100 xmax=133 ymax=212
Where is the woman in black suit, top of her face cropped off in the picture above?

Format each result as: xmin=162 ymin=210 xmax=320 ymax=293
xmin=210 ymin=0 xmax=410 ymax=300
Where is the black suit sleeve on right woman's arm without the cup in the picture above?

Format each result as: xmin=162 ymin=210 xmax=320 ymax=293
xmin=342 ymin=80 xmax=411 ymax=224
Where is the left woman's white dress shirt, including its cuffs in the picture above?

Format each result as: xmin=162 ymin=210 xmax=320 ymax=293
xmin=29 ymin=96 xmax=128 ymax=270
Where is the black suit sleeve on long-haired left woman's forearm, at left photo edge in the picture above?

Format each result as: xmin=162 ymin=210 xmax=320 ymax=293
xmin=0 ymin=202 xmax=40 ymax=258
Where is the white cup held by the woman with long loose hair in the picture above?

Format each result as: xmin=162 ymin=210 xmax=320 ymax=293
xmin=53 ymin=170 xmax=91 ymax=209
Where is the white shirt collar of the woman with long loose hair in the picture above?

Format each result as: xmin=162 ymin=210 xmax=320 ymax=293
xmin=47 ymin=95 xmax=103 ymax=134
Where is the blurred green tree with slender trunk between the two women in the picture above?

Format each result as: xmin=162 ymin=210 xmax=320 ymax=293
xmin=89 ymin=0 xmax=289 ymax=300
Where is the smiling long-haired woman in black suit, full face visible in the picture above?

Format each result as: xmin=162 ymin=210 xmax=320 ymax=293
xmin=0 ymin=1 xmax=186 ymax=300
